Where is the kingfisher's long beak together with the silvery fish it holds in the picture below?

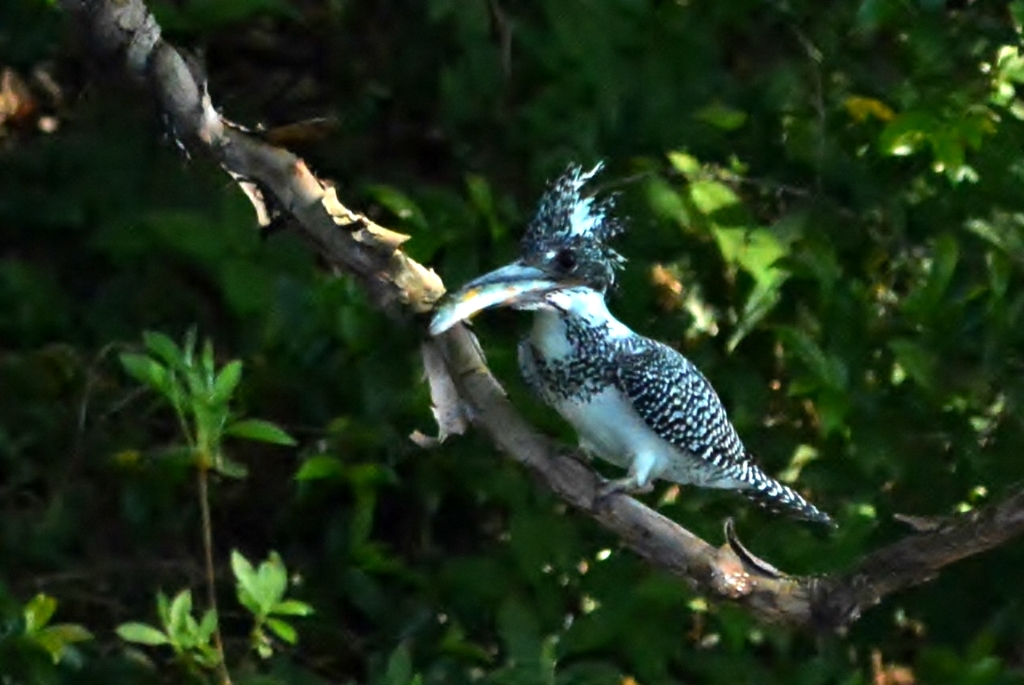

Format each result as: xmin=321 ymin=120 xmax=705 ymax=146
xmin=430 ymin=261 xmax=565 ymax=336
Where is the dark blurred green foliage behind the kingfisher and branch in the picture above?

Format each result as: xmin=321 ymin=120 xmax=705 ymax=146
xmin=0 ymin=0 xmax=1024 ymax=685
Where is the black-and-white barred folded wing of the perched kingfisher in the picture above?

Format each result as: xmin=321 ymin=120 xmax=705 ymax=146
xmin=616 ymin=339 xmax=750 ymax=477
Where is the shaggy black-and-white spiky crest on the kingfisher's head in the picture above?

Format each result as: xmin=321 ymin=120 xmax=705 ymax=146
xmin=521 ymin=163 xmax=626 ymax=286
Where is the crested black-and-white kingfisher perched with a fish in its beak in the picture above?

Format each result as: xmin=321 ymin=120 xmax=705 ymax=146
xmin=430 ymin=164 xmax=834 ymax=525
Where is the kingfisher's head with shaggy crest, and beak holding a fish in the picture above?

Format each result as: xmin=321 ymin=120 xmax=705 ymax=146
xmin=430 ymin=164 xmax=625 ymax=335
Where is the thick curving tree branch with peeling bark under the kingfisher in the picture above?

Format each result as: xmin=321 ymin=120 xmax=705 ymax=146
xmin=61 ymin=0 xmax=1024 ymax=630
